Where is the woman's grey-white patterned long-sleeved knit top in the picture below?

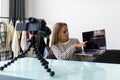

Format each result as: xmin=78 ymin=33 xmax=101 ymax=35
xmin=52 ymin=38 xmax=81 ymax=60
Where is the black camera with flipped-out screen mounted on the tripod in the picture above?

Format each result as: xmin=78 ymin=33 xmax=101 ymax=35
xmin=16 ymin=17 xmax=51 ymax=37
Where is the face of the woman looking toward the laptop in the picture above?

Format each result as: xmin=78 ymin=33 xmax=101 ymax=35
xmin=59 ymin=25 xmax=69 ymax=43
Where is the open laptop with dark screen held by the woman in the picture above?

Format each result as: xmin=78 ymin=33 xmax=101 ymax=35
xmin=82 ymin=29 xmax=106 ymax=54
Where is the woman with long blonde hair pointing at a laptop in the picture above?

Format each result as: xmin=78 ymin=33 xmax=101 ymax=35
xmin=51 ymin=22 xmax=86 ymax=60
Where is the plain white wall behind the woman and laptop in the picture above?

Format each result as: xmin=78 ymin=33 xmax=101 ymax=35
xmin=26 ymin=0 xmax=120 ymax=49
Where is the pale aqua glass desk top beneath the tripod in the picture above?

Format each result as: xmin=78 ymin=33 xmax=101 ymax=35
xmin=0 ymin=58 xmax=120 ymax=80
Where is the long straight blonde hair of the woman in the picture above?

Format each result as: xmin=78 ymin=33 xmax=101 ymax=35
xmin=51 ymin=22 xmax=67 ymax=46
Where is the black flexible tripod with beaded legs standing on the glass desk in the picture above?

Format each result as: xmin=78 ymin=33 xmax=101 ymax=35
xmin=0 ymin=34 xmax=55 ymax=76
